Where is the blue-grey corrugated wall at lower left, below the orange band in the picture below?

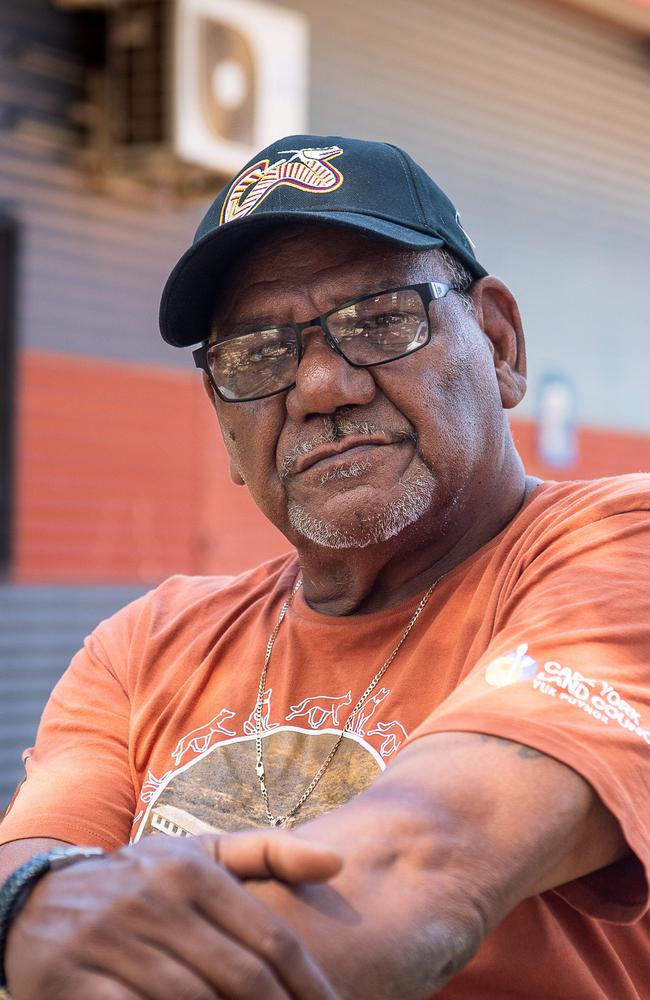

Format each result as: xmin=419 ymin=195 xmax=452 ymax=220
xmin=0 ymin=584 xmax=144 ymax=815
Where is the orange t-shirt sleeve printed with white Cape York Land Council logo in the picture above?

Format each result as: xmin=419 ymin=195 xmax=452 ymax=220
xmin=411 ymin=509 xmax=650 ymax=923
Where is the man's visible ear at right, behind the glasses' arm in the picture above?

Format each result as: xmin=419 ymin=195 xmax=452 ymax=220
xmin=470 ymin=274 xmax=526 ymax=410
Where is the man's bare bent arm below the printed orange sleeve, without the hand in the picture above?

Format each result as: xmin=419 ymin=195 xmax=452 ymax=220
xmin=246 ymin=733 xmax=626 ymax=1000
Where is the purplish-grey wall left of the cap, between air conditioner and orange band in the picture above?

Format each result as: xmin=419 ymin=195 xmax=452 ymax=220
xmin=0 ymin=146 xmax=202 ymax=367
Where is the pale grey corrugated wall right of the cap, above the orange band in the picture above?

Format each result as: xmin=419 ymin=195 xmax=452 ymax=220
xmin=292 ymin=0 xmax=650 ymax=431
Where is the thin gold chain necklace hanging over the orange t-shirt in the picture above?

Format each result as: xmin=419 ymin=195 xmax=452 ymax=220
xmin=255 ymin=573 xmax=446 ymax=826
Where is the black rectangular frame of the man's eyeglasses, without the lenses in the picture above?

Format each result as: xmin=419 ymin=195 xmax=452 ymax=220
xmin=192 ymin=278 xmax=456 ymax=403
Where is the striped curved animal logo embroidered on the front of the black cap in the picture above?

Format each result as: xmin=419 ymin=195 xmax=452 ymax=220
xmin=219 ymin=146 xmax=343 ymax=224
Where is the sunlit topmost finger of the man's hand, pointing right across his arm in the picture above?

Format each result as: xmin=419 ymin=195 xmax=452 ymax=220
xmin=213 ymin=830 xmax=343 ymax=884
